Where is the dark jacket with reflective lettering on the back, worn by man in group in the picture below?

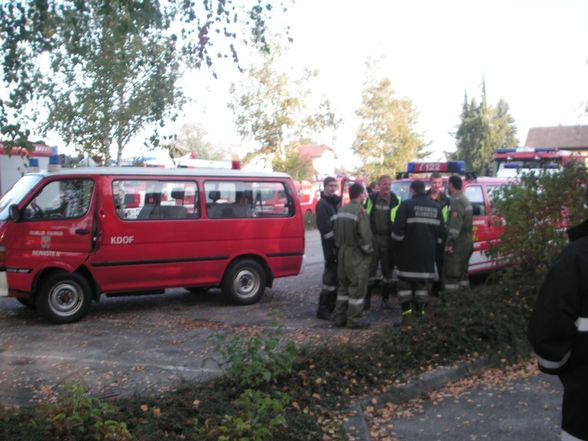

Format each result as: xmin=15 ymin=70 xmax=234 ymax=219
xmin=392 ymin=194 xmax=445 ymax=280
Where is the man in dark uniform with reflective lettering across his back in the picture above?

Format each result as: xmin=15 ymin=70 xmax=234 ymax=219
xmin=392 ymin=181 xmax=445 ymax=318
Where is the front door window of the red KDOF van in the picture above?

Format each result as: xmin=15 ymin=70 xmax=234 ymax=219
xmin=23 ymin=179 xmax=94 ymax=220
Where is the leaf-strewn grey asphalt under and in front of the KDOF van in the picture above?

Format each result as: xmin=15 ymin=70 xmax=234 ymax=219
xmin=0 ymin=230 xmax=399 ymax=404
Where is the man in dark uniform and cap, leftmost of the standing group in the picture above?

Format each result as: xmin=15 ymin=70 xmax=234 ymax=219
xmin=316 ymin=176 xmax=341 ymax=320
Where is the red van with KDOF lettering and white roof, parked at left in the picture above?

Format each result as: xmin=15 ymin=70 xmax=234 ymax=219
xmin=0 ymin=168 xmax=304 ymax=323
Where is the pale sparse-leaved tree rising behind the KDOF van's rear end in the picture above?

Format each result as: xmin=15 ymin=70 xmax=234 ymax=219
xmin=228 ymin=48 xmax=339 ymax=171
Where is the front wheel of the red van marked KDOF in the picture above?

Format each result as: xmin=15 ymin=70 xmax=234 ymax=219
xmin=37 ymin=271 xmax=92 ymax=323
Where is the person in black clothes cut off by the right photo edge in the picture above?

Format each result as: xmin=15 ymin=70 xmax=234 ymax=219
xmin=528 ymin=187 xmax=588 ymax=441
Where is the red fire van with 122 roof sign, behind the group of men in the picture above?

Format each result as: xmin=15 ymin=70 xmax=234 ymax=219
xmin=392 ymin=161 xmax=513 ymax=274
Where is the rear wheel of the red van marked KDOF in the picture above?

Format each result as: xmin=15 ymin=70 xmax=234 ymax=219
xmin=222 ymin=259 xmax=265 ymax=305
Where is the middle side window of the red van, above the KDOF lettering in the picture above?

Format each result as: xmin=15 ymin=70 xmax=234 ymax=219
xmin=112 ymin=179 xmax=200 ymax=220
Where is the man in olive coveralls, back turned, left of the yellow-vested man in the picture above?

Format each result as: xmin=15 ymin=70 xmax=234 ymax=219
xmin=333 ymin=183 xmax=373 ymax=328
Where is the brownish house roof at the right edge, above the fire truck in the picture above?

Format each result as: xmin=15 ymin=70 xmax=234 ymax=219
xmin=525 ymin=126 xmax=588 ymax=150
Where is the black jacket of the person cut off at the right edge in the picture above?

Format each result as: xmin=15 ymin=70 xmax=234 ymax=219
xmin=528 ymin=219 xmax=588 ymax=375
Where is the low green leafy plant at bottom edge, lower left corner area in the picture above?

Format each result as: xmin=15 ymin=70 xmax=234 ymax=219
xmin=51 ymin=384 xmax=132 ymax=441
